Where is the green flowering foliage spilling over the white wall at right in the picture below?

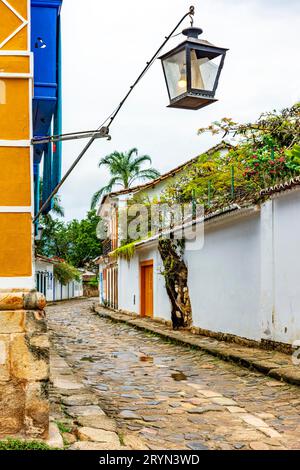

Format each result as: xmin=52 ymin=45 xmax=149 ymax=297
xmin=162 ymin=104 xmax=300 ymax=210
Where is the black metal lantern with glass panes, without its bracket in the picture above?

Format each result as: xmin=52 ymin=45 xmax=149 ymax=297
xmin=160 ymin=27 xmax=228 ymax=109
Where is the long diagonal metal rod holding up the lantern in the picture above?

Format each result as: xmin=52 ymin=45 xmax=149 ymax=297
xmin=33 ymin=6 xmax=195 ymax=223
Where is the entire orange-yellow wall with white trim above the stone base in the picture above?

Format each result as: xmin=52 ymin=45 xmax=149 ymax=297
xmin=0 ymin=0 xmax=33 ymax=282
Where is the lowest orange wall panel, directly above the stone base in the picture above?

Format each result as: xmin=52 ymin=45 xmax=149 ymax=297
xmin=0 ymin=213 xmax=32 ymax=277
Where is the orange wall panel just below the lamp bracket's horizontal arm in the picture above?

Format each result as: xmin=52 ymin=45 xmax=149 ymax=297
xmin=0 ymin=147 xmax=31 ymax=206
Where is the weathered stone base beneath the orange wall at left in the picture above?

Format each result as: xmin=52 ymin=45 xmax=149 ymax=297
xmin=0 ymin=291 xmax=49 ymax=439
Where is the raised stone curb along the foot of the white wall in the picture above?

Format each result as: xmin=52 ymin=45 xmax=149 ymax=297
xmin=92 ymin=305 xmax=300 ymax=386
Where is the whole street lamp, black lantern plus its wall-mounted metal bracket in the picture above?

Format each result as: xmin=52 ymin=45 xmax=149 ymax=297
xmin=34 ymin=5 xmax=228 ymax=222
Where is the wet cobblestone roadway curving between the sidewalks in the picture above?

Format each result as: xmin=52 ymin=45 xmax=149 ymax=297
xmin=47 ymin=300 xmax=300 ymax=450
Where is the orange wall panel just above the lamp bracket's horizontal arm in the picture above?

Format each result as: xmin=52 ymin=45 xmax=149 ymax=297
xmin=0 ymin=78 xmax=30 ymax=140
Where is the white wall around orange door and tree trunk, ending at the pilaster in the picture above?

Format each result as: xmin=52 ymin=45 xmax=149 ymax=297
xmin=119 ymin=213 xmax=261 ymax=339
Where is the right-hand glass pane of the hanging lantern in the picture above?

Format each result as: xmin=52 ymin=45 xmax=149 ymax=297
xmin=191 ymin=49 xmax=221 ymax=91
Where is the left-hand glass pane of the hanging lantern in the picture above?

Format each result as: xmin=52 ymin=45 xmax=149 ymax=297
xmin=163 ymin=50 xmax=187 ymax=99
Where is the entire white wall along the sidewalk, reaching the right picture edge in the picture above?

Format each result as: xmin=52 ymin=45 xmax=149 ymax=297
xmin=115 ymin=190 xmax=300 ymax=344
